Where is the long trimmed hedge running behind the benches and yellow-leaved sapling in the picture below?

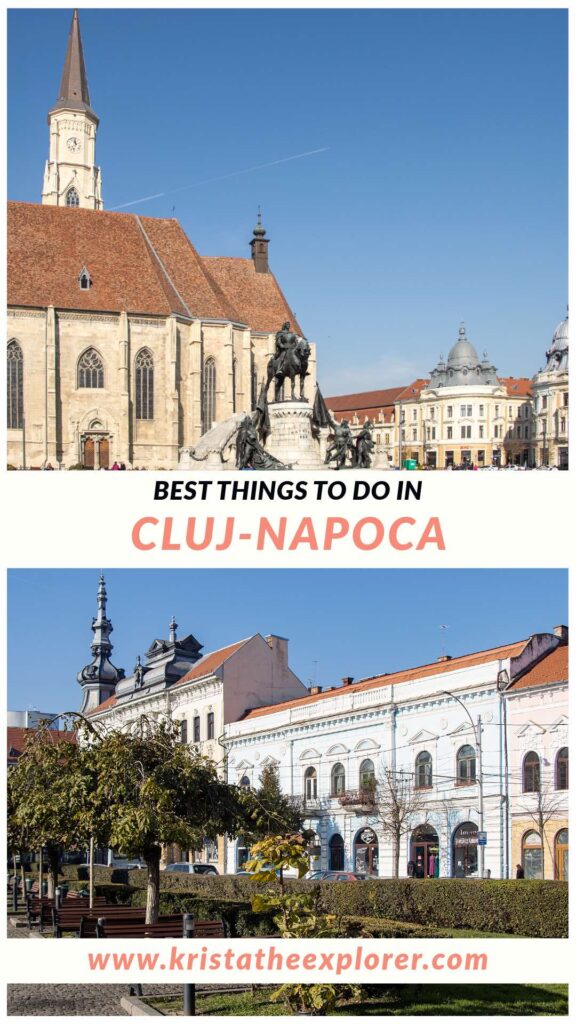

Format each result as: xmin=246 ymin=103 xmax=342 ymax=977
xmin=23 ymin=864 xmax=568 ymax=939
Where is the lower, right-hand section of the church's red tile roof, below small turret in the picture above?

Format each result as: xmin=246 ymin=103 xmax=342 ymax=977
xmin=202 ymin=256 xmax=302 ymax=334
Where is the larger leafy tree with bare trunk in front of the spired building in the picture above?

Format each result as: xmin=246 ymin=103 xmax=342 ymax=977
xmin=87 ymin=718 xmax=246 ymax=924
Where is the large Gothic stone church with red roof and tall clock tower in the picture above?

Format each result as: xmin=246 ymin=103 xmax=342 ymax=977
xmin=7 ymin=11 xmax=316 ymax=469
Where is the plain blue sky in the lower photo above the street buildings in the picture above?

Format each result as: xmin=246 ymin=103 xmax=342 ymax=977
xmin=8 ymin=569 xmax=568 ymax=713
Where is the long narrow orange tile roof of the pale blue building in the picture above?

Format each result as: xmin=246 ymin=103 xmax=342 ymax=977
xmin=239 ymin=640 xmax=528 ymax=720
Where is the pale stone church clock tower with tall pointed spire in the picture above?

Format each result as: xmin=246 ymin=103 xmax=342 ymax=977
xmin=42 ymin=10 xmax=104 ymax=210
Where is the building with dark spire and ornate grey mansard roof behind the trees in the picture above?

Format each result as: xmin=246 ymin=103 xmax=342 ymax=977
xmin=77 ymin=577 xmax=307 ymax=871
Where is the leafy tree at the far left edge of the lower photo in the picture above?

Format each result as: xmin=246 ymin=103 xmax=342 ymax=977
xmin=8 ymin=725 xmax=95 ymax=895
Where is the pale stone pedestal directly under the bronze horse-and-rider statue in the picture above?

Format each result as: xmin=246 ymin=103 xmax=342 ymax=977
xmin=265 ymin=400 xmax=323 ymax=469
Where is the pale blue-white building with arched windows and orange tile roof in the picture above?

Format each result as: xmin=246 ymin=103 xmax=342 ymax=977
xmin=224 ymin=633 xmax=564 ymax=878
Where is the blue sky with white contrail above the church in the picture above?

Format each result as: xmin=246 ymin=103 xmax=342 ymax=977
xmin=8 ymin=9 xmax=567 ymax=394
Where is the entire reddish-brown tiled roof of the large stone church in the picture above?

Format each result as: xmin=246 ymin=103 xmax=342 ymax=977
xmin=8 ymin=203 xmax=300 ymax=331
